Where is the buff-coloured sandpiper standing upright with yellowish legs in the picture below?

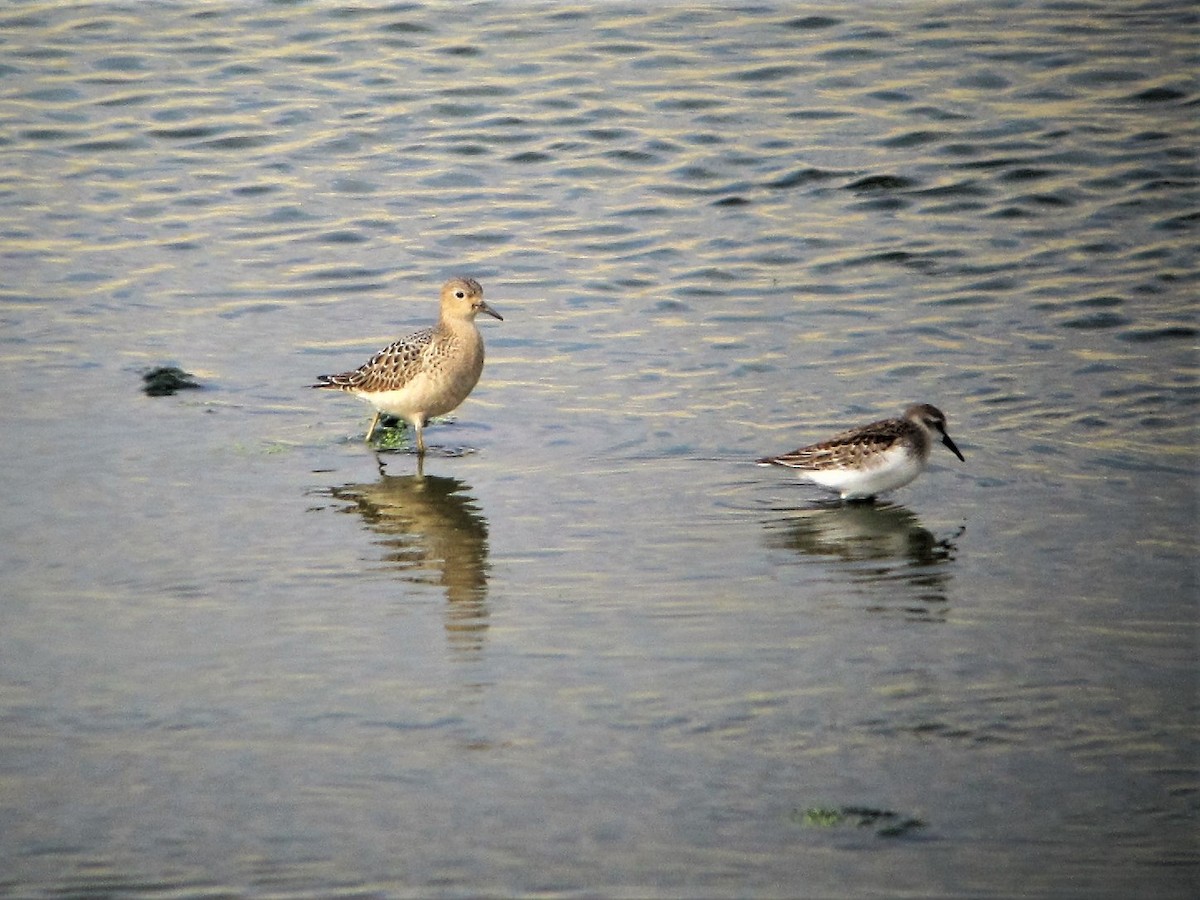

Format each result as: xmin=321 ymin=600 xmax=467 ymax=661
xmin=312 ymin=278 xmax=504 ymax=455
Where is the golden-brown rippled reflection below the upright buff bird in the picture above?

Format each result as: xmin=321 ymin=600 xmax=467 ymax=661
xmin=329 ymin=467 xmax=487 ymax=652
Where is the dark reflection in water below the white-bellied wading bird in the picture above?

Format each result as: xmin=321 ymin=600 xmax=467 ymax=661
xmin=766 ymin=502 xmax=961 ymax=622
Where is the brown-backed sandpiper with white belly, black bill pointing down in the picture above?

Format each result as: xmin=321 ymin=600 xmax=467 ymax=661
xmin=758 ymin=403 xmax=966 ymax=500
